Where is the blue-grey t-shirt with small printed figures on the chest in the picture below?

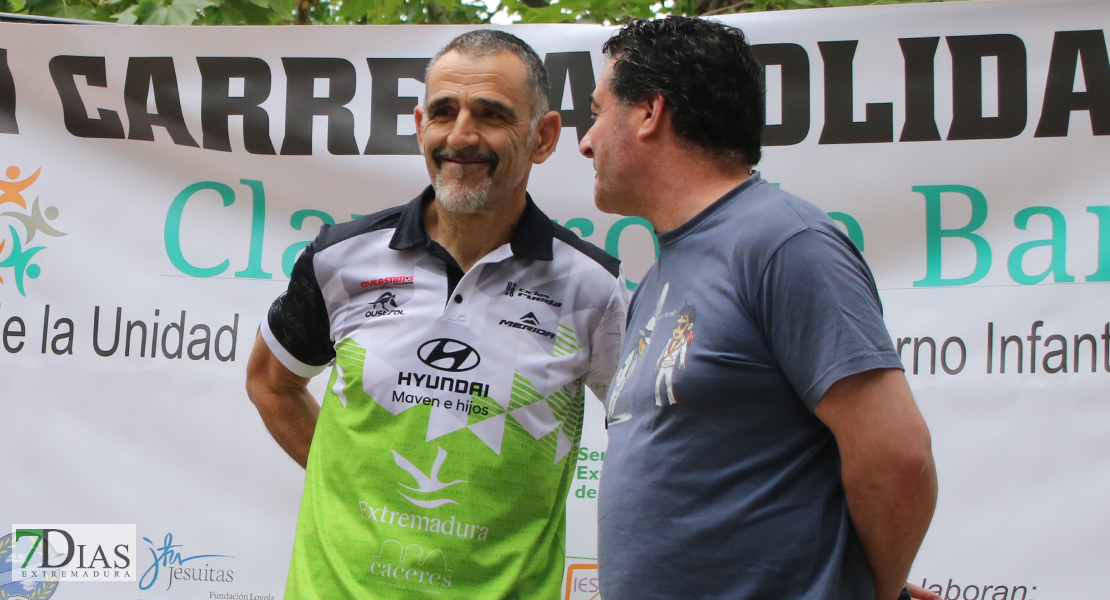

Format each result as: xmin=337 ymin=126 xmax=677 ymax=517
xmin=598 ymin=175 xmax=901 ymax=600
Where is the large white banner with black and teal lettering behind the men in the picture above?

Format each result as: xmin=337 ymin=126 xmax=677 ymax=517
xmin=0 ymin=1 xmax=1110 ymax=600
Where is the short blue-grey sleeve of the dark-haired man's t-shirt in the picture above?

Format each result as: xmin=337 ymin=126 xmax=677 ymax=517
xmin=756 ymin=228 xmax=902 ymax=410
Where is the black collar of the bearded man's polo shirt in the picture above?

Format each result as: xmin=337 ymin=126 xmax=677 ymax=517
xmin=390 ymin=185 xmax=555 ymax=261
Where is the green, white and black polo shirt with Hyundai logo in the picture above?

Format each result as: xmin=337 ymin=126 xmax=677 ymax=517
xmin=262 ymin=187 xmax=627 ymax=600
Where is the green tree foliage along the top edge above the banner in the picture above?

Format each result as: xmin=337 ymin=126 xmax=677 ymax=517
xmin=0 ymin=0 xmax=946 ymax=26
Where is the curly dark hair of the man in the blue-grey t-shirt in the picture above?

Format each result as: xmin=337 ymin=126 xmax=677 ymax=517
xmin=602 ymin=16 xmax=766 ymax=165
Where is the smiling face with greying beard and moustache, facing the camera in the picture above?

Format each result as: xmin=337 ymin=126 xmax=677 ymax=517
xmin=416 ymin=51 xmax=546 ymax=214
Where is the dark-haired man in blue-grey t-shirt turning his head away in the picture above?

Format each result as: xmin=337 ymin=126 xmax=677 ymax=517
xmin=581 ymin=18 xmax=937 ymax=600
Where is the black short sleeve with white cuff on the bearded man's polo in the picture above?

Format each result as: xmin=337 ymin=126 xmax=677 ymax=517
xmin=260 ymin=238 xmax=335 ymax=377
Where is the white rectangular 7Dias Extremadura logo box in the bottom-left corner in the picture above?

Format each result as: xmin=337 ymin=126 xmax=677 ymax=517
xmin=10 ymin=525 xmax=135 ymax=582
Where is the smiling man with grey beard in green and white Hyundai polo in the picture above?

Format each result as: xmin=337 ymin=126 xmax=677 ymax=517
xmin=246 ymin=30 xmax=626 ymax=600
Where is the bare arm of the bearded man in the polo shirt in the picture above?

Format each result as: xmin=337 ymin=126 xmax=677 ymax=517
xmin=246 ymin=334 xmax=320 ymax=467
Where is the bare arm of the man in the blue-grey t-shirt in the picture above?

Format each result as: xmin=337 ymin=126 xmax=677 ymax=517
xmin=814 ymin=369 xmax=937 ymax=600
